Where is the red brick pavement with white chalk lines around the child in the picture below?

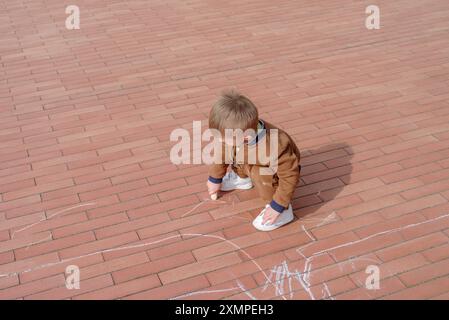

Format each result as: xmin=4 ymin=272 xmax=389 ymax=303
xmin=0 ymin=0 xmax=449 ymax=299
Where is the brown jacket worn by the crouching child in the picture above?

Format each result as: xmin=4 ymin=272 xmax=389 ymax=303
xmin=209 ymin=121 xmax=300 ymax=207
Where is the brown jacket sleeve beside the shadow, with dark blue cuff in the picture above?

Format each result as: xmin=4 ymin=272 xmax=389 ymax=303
xmin=270 ymin=146 xmax=300 ymax=212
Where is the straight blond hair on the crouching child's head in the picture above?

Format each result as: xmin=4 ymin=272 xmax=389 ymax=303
xmin=209 ymin=89 xmax=259 ymax=132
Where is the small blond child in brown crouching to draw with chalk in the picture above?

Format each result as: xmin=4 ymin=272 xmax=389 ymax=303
xmin=207 ymin=90 xmax=301 ymax=231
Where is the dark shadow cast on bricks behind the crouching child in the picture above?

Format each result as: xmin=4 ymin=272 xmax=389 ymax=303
xmin=292 ymin=143 xmax=353 ymax=219
